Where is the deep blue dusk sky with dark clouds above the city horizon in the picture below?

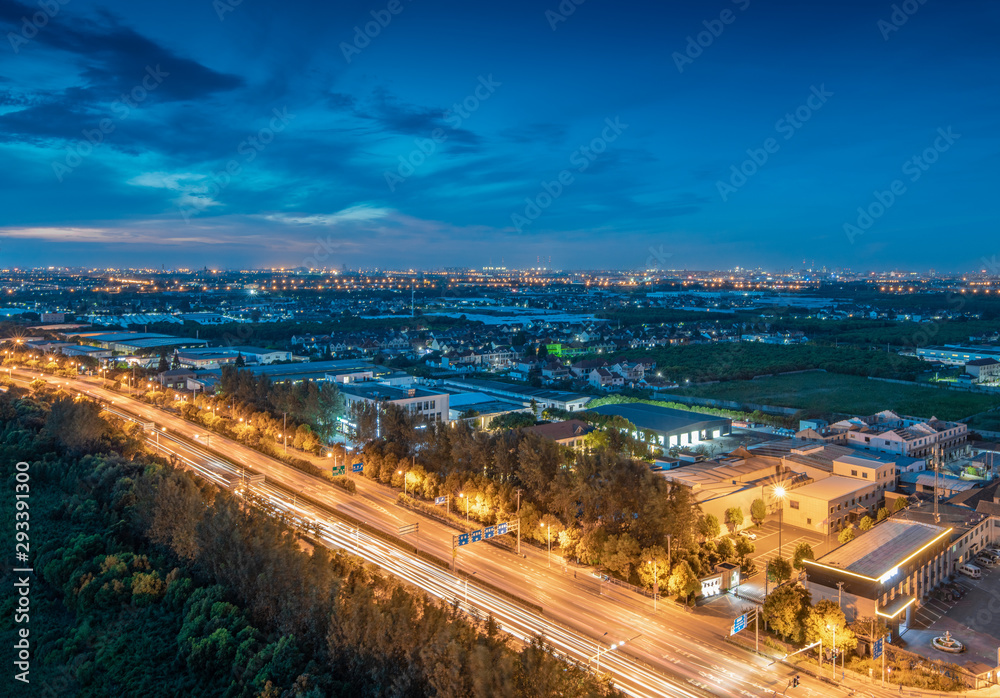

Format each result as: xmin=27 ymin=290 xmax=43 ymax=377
xmin=0 ymin=0 xmax=1000 ymax=270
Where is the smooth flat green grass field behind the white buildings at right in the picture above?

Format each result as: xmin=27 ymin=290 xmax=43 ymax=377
xmin=670 ymin=372 xmax=1000 ymax=422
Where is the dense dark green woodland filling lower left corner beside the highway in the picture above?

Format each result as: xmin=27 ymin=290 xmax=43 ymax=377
xmin=0 ymin=388 xmax=612 ymax=698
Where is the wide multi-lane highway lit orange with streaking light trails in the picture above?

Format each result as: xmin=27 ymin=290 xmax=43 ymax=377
xmin=14 ymin=372 xmax=897 ymax=698
